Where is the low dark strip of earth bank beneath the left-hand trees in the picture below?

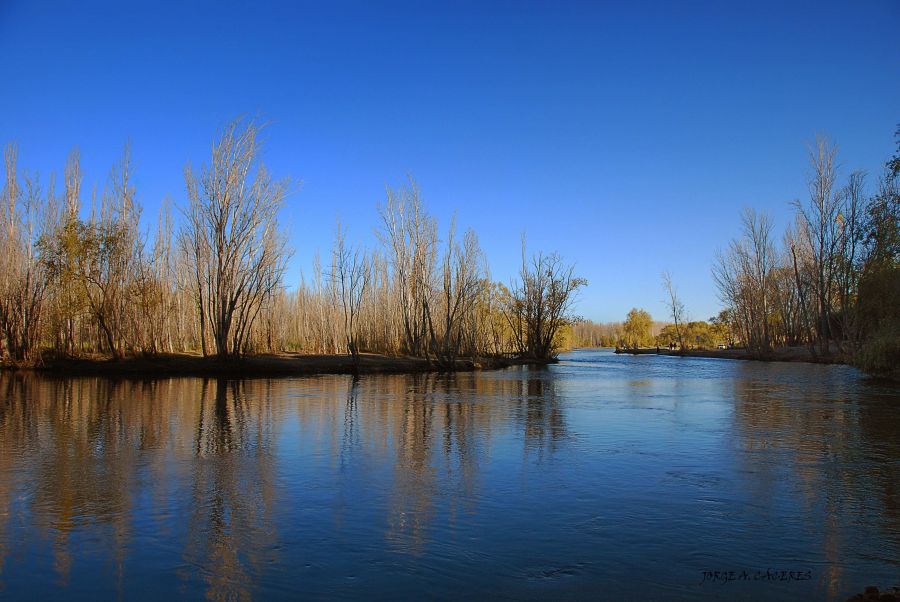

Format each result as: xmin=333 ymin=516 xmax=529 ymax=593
xmin=2 ymin=353 xmax=551 ymax=378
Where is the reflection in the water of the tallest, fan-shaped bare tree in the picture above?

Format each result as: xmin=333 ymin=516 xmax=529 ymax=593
xmin=185 ymin=379 xmax=277 ymax=600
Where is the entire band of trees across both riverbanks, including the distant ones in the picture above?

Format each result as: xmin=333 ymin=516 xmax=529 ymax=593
xmin=0 ymin=120 xmax=900 ymax=377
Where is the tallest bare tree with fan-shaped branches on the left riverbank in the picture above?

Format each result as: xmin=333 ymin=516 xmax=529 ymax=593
xmin=179 ymin=120 xmax=289 ymax=358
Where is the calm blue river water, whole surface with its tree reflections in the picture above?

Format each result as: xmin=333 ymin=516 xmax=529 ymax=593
xmin=0 ymin=351 xmax=900 ymax=600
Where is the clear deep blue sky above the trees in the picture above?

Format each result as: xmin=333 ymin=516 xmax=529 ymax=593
xmin=0 ymin=0 xmax=900 ymax=321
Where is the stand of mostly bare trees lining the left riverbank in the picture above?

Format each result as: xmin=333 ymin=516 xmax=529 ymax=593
xmin=0 ymin=116 xmax=586 ymax=365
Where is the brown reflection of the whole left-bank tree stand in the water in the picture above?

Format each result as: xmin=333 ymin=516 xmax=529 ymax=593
xmin=0 ymin=370 xmax=566 ymax=599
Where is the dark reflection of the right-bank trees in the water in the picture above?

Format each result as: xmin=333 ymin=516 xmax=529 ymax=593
xmin=733 ymin=366 xmax=900 ymax=600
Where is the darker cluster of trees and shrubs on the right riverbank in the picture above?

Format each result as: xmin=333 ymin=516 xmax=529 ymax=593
xmin=713 ymin=131 xmax=900 ymax=377
